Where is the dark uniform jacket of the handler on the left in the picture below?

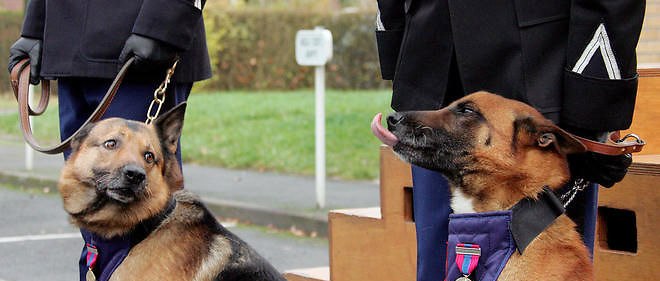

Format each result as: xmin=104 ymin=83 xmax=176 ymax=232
xmin=21 ymin=0 xmax=211 ymax=82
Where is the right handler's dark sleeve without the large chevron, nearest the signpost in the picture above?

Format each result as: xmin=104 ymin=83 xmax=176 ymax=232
xmin=376 ymin=0 xmax=406 ymax=80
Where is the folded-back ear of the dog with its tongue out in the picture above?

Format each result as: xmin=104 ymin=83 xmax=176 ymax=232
xmin=514 ymin=117 xmax=586 ymax=155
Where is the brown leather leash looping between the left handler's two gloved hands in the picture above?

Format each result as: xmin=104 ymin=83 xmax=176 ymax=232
xmin=11 ymin=57 xmax=135 ymax=154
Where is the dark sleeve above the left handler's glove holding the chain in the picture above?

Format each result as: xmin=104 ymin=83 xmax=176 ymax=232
xmin=132 ymin=0 xmax=206 ymax=50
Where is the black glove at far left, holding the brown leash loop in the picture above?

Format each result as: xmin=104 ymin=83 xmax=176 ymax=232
xmin=7 ymin=37 xmax=41 ymax=85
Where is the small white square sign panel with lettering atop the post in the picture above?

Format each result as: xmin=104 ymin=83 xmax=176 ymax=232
xmin=296 ymin=27 xmax=332 ymax=66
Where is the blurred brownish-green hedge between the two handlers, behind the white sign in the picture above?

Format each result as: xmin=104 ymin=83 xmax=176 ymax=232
xmin=201 ymin=9 xmax=389 ymax=90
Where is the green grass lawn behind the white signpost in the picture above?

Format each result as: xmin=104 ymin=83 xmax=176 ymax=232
xmin=0 ymin=90 xmax=392 ymax=179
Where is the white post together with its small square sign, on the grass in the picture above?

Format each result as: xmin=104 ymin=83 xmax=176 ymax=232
xmin=296 ymin=27 xmax=332 ymax=208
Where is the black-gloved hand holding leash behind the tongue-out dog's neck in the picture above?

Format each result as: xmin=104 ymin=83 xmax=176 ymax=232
xmin=561 ymin=126 xmax=632 ymax=187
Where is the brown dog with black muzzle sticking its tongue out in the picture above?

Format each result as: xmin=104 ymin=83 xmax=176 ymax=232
xmin=372 ymin=92 xmax=593 ymax=281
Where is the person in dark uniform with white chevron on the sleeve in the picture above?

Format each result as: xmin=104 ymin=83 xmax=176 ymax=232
xmin=376 ymin=0 xmax=645 ymax=280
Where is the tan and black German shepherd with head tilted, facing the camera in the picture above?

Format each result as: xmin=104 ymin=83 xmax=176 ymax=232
xmin=59 ymin=103 xmax=286 ymax=281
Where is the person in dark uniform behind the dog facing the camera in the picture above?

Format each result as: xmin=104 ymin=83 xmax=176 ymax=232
xmin=9 ymin=0 xmax=211 ymax=280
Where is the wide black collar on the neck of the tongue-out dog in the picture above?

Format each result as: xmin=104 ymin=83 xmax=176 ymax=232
xmin=509 ymin=187 xmax=566 ymax=254
